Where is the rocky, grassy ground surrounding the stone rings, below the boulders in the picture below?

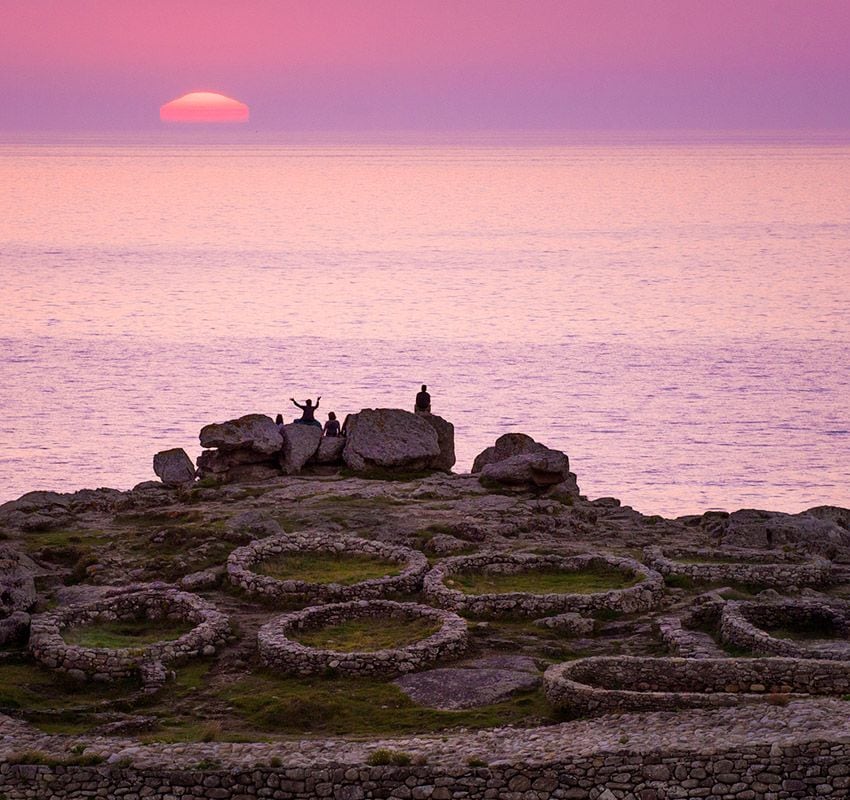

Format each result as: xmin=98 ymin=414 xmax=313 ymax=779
xmin=0 ymin=418 xmax=850 ymax=765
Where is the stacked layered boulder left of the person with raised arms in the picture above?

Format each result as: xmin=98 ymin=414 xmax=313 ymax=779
xmin=198 ymin=414 xmax=283 ymax=483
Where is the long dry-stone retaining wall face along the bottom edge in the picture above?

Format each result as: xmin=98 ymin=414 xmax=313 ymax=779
xmin=0 ymin=741 xmax=850 ymax=800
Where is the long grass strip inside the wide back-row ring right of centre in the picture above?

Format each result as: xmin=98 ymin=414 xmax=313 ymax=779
xmin=446 ymin=568 xmax=640 ymax=594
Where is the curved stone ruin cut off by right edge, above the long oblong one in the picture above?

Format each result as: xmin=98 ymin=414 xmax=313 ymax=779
xmin=720 ymin=598 xmax=850 ymax=661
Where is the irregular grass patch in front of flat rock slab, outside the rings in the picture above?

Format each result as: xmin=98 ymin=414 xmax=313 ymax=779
xmin=215 ymin=672 xmax=555 ymax=735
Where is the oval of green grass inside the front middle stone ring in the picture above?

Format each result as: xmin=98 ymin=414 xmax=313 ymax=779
xmin=297 ymin=617 xmax=440 ymax=653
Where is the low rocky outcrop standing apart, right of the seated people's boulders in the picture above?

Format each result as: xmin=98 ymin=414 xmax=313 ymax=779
xmin=472 ymin=433 xmax=579 ymax=490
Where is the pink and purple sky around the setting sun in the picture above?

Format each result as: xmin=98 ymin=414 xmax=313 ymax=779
xmin=0 ymin=0 xmax=850 ymax=130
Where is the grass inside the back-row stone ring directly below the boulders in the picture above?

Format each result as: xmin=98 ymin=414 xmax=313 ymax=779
xmin=255 ymin=551 xmax=403 ymax=586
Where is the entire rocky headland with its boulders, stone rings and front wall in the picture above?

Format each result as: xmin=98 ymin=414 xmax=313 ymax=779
xmin=0 ymin=409 xmax=850 ymax=800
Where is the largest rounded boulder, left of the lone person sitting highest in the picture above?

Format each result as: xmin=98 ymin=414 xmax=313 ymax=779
xmin=342 ymin=408 xmax=441 ymax=472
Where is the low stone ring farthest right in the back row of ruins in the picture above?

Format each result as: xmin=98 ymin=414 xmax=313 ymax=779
xmin=644 ymin=546 xmax=832 ymax=589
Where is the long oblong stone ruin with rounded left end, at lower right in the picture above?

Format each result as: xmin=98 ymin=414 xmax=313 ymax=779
xmin=543 ymin=656 xmax=850 ymax=715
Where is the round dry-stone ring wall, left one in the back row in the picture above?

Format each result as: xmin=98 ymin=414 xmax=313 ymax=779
xmin=227 ymin=534 xmax=428 ymax=603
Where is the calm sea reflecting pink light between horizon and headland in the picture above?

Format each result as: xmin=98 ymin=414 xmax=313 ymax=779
xmin=0 ymin=133 xmax=850 ymax=515
